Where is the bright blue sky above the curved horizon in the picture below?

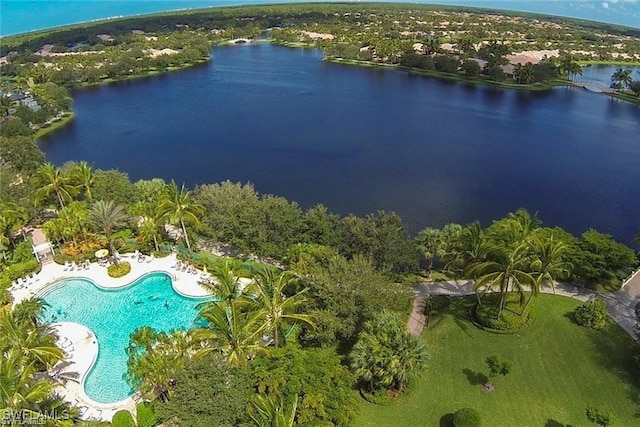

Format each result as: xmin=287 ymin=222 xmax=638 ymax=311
xmin=0 ymin=0 xmax=640 ymax=35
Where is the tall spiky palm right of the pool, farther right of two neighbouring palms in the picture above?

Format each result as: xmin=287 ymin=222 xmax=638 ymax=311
xmin=247 ymin=268 xmax=315 ymax=348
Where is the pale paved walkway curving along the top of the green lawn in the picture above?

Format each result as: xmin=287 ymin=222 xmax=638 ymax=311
xmin=407 ymin=270 xmax=640 ymax=337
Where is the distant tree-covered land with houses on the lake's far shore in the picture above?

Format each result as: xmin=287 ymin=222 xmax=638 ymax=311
xmin=0 ymin=3 xmax=640 ymax=137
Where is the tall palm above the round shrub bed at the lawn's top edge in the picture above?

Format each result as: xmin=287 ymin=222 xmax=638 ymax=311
xmin=465 ymin=243 xmax=535 ymax=319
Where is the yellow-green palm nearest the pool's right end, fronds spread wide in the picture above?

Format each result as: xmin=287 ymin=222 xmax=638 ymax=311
xmin=192 ymin=299 xmax=267 ymax=365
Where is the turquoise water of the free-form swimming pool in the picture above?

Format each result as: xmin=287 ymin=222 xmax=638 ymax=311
xmin=42 ymin=273 xmax=210 ymax=403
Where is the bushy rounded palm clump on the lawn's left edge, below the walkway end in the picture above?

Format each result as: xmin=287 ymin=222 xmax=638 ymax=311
xmin=349 ymin=311 xmax=429 ymax=393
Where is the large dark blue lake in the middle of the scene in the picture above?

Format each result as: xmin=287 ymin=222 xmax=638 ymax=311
xmin=41 ymin=44 xmax=640 ymax=243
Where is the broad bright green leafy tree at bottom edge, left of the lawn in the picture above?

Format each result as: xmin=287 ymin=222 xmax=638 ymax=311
xmin=251 ymin=346 xmax=358 ymax=426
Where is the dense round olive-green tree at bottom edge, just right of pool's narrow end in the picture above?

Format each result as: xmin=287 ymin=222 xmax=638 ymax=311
xmin=156 ymin=354 xmax=254 ymax=426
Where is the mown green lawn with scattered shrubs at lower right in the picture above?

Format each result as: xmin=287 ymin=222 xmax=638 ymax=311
xmin=358 ymin=295 xmax=640 ymax=427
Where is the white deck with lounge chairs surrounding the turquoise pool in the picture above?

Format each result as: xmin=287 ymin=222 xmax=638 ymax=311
xmin=12 ymin=254 xmax=225 ymax=421
